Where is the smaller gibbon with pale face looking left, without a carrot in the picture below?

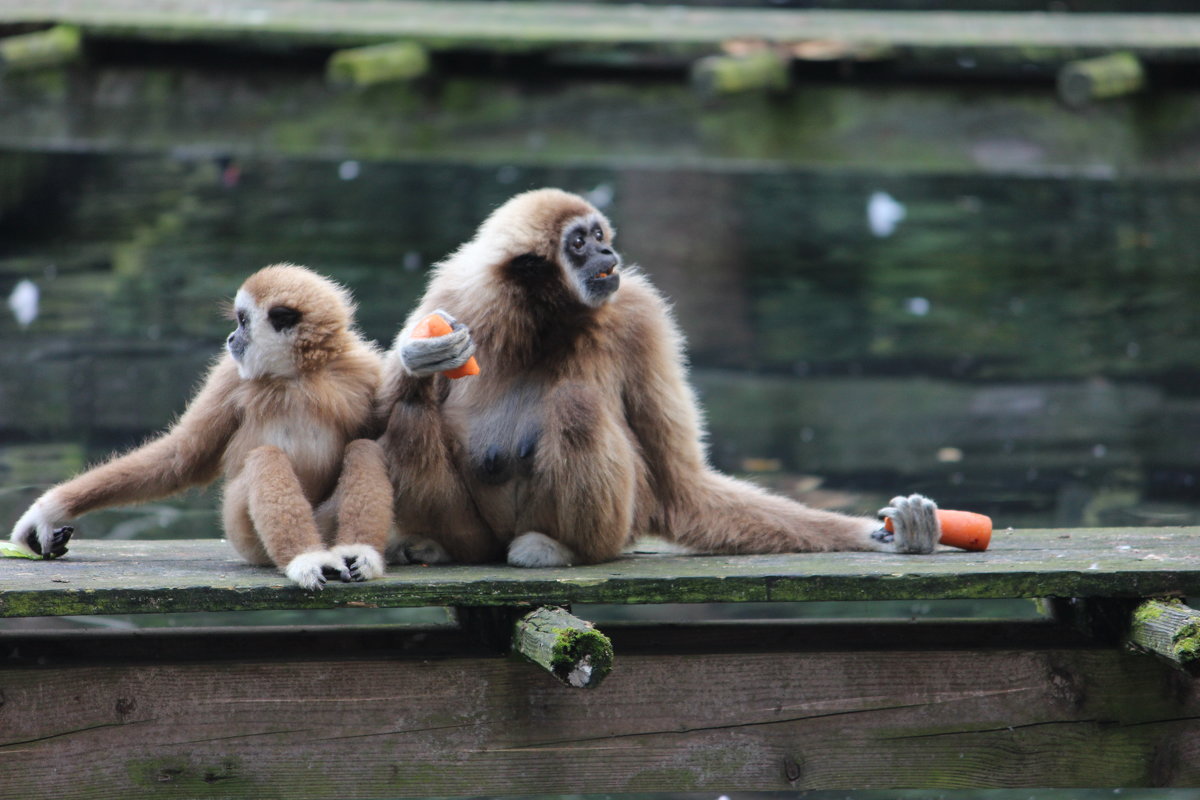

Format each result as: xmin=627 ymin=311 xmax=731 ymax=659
xmin=11 ymin=264 xmax=392 ymax=589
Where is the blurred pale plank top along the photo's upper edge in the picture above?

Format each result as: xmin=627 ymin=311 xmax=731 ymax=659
xmin=0 ymin=0 xmax=1200 ymax=58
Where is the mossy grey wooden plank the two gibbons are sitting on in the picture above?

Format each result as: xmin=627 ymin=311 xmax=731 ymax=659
xmin=0 ymin=528 xmax=1200 ymax=616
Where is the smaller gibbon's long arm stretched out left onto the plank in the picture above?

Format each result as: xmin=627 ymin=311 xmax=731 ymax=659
xmin=11 ymin=356 xmax=239 ymax=553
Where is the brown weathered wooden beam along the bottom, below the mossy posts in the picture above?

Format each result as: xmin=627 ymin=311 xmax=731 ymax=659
xmin=0 ymin=642 xmax=1200 ymax=800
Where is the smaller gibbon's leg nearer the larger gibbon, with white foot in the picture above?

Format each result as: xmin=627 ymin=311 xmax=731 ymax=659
xmin=323 ymin=439 xmax=392 ymax=581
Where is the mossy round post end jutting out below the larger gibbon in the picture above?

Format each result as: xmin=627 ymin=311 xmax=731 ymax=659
xmin=512 ymin=607 xmax=612 ymax=688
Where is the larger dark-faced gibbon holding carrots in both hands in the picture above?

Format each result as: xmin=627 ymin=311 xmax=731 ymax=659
xmin=379 ymin=190 xmax=938 ymax=567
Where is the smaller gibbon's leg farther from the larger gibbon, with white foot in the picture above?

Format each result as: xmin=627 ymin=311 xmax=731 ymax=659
xmin=239 ymin=445 xmax=352 ymax=590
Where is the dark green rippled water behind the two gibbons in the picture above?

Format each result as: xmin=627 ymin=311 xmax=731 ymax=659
xmin=0 ymin=151 xmax=1200 ymax=537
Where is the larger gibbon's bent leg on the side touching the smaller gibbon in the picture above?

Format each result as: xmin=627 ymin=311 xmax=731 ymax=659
xmin=379 ymin=374 xmax=503 ymax=564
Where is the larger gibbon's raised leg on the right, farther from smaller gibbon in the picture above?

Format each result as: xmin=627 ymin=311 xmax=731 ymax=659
xmin=508 ymin=384 xmax=637 ymax=567
